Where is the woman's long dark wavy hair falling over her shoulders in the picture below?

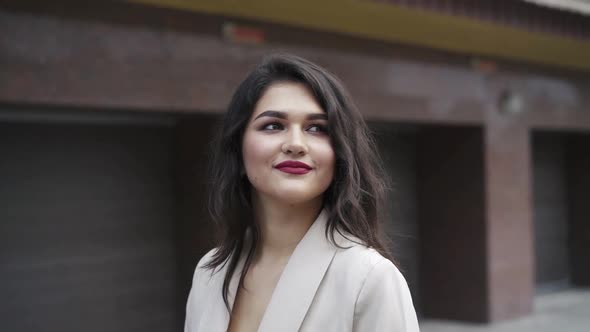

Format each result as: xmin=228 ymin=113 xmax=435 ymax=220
xmin=205 ymin=54 xmax=391 ymax=310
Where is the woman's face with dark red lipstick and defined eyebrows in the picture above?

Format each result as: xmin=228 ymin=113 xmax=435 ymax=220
xmin=242 ymin=82 xmax=335 ymax=204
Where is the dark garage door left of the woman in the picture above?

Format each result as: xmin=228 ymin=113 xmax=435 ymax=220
xmin=0 ymin=121 xmax=180 ymax=332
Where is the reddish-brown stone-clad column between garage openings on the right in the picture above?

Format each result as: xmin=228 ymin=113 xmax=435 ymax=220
xmin=482 ymin=120 xmax=534 ymax=321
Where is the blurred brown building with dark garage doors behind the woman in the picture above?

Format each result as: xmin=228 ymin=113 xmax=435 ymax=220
xmin=0 ymin=0 xmax=590 ymax=331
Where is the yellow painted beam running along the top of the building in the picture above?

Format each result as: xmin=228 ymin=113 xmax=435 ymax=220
xmin=128 ymin=0 xmax=590 ymax=71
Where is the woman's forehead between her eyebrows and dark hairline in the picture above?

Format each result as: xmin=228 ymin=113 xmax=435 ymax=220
xmin=252 ymin=82 xmax=324 ymax=117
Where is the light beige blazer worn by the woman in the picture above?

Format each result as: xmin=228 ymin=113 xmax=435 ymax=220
xmin=184 ymin=211 xmax=419 ymax=332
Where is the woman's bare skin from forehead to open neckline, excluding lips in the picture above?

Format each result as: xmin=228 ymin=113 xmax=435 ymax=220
xmin=228 ymin=82 xmax=335 ymax=332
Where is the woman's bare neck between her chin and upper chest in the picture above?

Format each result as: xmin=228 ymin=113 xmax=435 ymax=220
xmin=253 ymin=195 xmax=322 ymax=262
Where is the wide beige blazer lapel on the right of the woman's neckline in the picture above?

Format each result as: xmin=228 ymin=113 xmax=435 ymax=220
xmin=258 ymin=210 xmax=337 ymax=332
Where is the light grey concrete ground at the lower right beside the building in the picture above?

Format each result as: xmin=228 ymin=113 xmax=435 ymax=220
xmin=420 ymin=289 xmax=590 ymax=332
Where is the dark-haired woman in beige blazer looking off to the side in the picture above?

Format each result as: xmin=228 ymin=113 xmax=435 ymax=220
xmin=185 ymin=55 xmax=418 ymax=332
